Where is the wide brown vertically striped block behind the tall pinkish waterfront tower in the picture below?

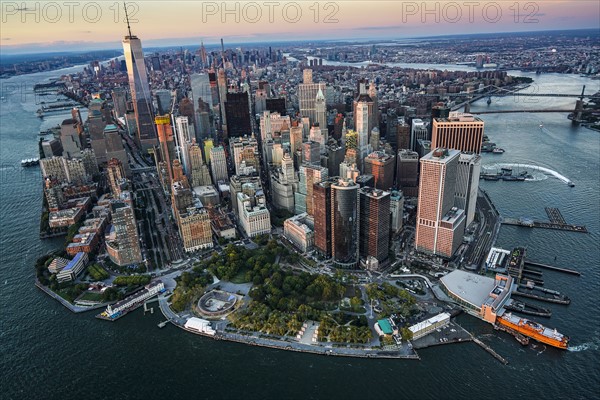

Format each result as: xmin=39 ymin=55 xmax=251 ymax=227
xmin=431 ymin=112 xmax=484 ymax=154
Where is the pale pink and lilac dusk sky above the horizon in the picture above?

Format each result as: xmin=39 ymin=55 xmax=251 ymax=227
xmin=0 ymin=0 xmax=600 ymax=55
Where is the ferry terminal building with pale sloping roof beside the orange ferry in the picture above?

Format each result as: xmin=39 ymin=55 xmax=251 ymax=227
xmin=440 ymin=270 xmax=514 ymax=324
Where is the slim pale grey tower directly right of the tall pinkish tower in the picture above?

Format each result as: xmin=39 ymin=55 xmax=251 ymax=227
xmin=454 ymin=153 xmax=481 ymax=226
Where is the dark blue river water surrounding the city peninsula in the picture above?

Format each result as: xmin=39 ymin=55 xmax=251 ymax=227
xmin=0 ymin=65 xmax=600 ymax=399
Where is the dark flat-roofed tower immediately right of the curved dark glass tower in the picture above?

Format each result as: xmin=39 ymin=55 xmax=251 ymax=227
xmin=359 ymin=187 xmax=390 ymax=266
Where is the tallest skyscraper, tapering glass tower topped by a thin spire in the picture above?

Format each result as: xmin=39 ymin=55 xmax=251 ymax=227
xmin=122 ymin=26 xmax=157 ymax=150
